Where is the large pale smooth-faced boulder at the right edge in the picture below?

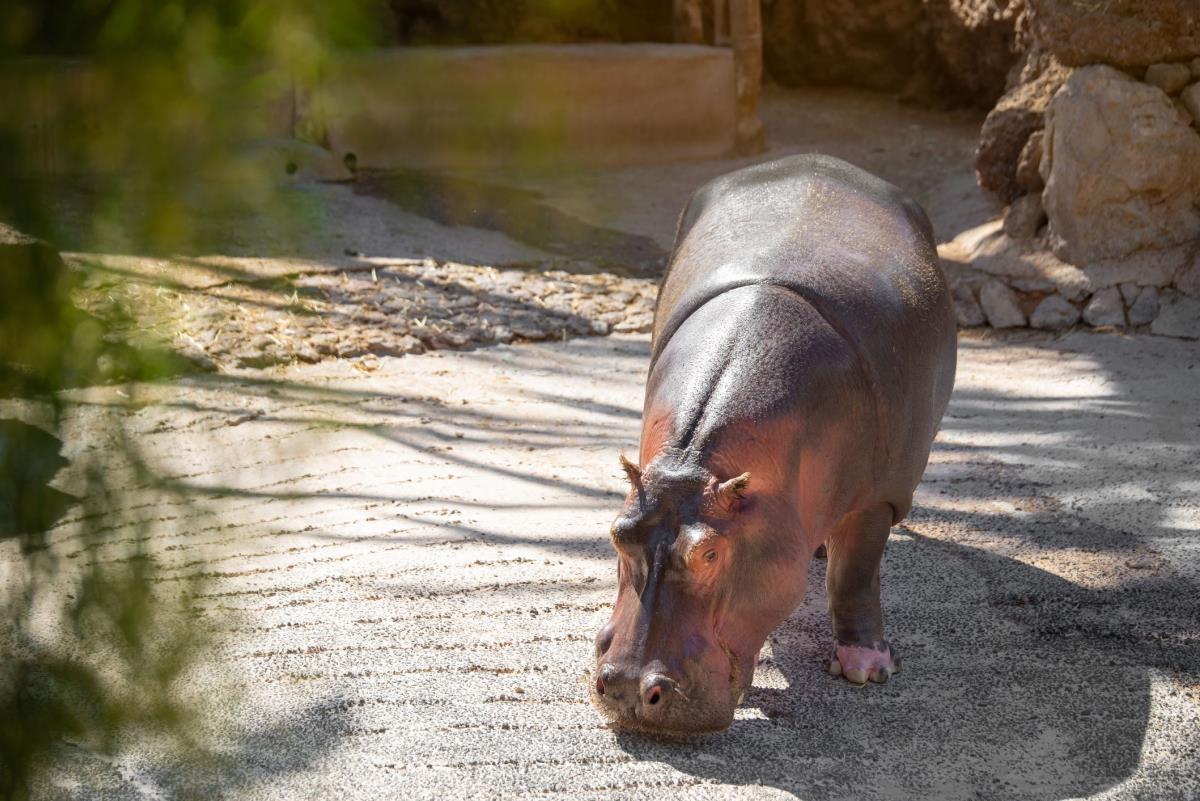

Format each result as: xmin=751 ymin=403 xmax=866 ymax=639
xmin=1042 ymin=66 xmax=1200 ymax=265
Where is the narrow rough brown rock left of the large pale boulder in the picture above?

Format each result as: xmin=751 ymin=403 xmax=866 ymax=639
xmin=976 ymin=50 xmax=1070 ymax=203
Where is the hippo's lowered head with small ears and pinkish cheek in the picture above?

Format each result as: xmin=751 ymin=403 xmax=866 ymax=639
xmin=592 ymin=457 xmax=805 ymax=735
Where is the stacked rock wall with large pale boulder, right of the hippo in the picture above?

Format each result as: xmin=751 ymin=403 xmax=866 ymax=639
xmin=943 ymin=0 xmax=1200 ymax=338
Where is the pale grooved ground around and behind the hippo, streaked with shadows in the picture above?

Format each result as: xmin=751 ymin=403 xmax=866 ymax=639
xmin=16 ymin=84 xmax=1200 ymax=800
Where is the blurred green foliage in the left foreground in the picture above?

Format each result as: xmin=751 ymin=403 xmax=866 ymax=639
xmin=0 ymin=0 xmax=378 ymax=799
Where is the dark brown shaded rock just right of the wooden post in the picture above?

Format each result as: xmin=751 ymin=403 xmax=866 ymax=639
xmin=763 ymin=0 xmax=923 ymax=91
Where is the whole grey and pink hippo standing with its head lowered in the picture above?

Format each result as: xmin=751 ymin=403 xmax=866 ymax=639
xmin=593 ymin=155 xmax=955 ymax=734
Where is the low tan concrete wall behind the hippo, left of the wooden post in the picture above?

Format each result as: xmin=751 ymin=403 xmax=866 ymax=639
xmin=309 ymin=44 xmax=737 ymax=168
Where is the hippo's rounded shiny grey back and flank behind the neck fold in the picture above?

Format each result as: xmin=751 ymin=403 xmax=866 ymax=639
xmin=650 ymin=155 xmax=956 ymax=513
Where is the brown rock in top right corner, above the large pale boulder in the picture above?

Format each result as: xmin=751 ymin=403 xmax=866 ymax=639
xmin=1028 ymin=0 xmax=1200 ymax=68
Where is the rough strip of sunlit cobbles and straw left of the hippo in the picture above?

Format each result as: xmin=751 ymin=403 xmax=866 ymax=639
xmin=72 ymin=254 xmax=656 ymax=371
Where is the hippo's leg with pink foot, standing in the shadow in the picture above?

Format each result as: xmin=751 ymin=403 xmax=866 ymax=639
xmin=826 ymin=504 xmax=900 ymax=685
